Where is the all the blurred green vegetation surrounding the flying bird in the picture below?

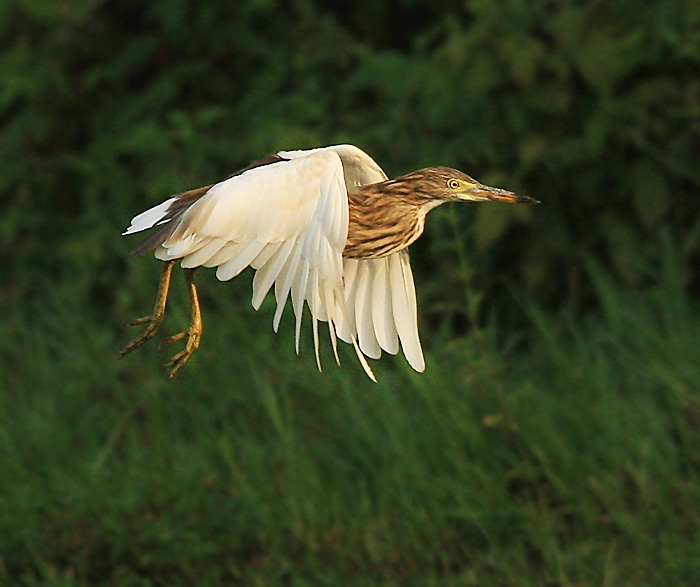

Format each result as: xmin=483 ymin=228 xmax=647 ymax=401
xmin=0 ymin=0 xmax=700 ymax=587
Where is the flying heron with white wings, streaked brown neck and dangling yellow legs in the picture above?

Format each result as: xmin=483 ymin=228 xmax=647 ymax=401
xmin=118 ymin=144 xmax=539 ymax=381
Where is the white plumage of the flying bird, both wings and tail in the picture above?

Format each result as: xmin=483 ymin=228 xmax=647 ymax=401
xmin=124 ymin=145 xmax=425 ymax=379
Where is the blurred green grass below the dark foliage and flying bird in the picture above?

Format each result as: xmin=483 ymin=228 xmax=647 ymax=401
xmin=0 ymin=255 xmax=700 ymax=587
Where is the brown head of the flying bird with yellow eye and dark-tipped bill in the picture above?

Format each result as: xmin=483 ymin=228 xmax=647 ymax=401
xmin=399 ymin=167 xmax=539 ymax=204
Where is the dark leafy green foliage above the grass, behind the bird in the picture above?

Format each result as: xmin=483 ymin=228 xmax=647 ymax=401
xmin=0 ymin=0 xmax=700 ymax=326
